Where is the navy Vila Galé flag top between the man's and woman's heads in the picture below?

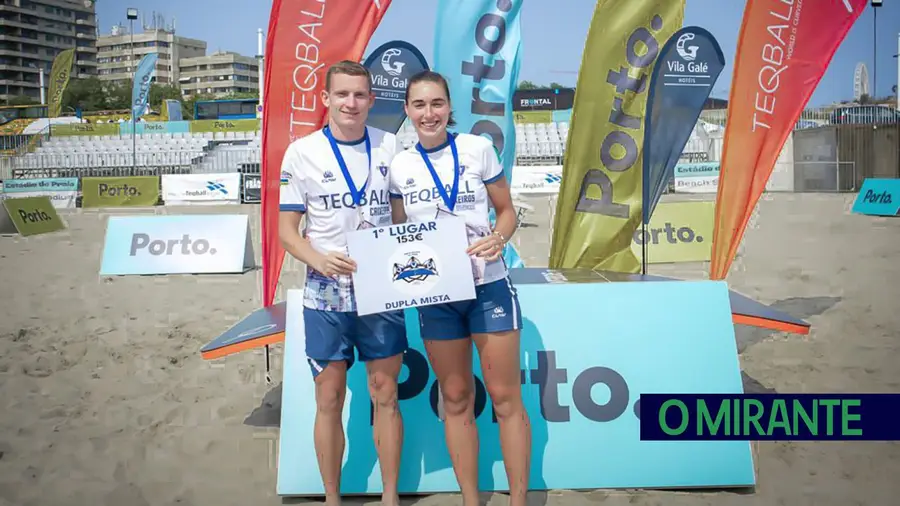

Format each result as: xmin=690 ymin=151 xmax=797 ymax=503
xmin=363 ymin=40 xmax=428 ymax=134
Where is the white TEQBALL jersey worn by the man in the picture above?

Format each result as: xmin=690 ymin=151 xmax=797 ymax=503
xmin=280 ymin=124 xmax=402 ymax=311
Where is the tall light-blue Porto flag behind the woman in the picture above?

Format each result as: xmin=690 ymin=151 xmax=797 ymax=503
xmin=434 ymin=0 xmax=524 ymax=268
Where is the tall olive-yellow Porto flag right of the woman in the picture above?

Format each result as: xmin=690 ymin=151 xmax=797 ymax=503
xmin=550 ymin=0 xmax=685 ymax=273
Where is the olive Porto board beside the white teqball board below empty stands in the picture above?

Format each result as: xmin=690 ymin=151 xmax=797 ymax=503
xmin=81 ymin=176 xmax=159 ymax=208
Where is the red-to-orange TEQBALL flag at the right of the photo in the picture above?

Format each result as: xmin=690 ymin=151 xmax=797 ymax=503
xmin=709 ymin=0 xmax=867 ymax=280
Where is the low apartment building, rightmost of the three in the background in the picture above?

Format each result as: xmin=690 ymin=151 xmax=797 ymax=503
xmin=179 ymin=51 xmax=259 ymax=97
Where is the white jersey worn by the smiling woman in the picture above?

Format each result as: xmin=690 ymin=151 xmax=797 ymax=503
xmin=390 ymin=133 xmax=508 ymax=285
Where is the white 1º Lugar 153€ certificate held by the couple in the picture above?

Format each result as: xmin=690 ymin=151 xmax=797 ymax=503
xmin=347 ymin=218 xmax=475 ymax=315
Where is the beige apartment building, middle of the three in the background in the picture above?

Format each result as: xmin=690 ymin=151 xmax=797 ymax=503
xmin=97 ymin=28 xmax=206 ymax=85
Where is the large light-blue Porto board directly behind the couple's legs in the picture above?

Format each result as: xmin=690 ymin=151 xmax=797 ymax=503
xmin=277 ymin=276 xmax=756 ymax=496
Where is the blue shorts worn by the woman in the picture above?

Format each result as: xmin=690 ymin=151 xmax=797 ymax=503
xmin=418 ymin=278 xmax=522 ymax=340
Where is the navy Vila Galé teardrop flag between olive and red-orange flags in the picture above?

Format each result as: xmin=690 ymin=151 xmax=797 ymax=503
xmin=642 ymin=26 xmax=725 ymax=224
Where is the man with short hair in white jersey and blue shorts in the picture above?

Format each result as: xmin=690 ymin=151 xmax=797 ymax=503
xmin=278 ymin=61 xmax=408 ymax=506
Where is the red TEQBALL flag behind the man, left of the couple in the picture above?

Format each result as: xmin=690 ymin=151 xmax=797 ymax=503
xmin=261 ymin=0 xmax=391 ymax=306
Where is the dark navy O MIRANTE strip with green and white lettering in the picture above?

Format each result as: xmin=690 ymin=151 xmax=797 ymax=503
xmin=640 ymin=394 xmax=900 ymax=441
